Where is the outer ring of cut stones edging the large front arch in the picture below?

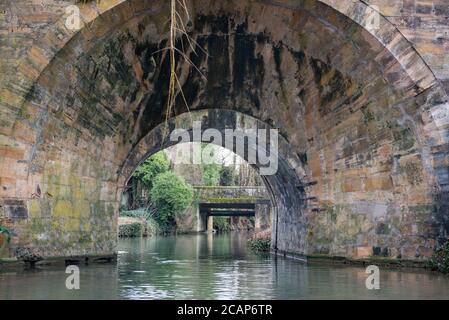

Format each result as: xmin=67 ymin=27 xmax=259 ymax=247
xmin=4 ymin=0 xmax=437 ymax=98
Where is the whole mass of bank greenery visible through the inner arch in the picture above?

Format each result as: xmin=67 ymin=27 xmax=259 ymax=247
xmin=119 ymin=144 xmax=261 ymax=236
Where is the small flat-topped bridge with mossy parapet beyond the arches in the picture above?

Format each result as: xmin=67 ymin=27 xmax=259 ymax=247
xmin=194 ymin=186 xmax=271 ymax=231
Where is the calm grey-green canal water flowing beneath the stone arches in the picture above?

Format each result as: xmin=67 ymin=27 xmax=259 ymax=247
xmin=0 ymin=233 xmax=449 ymax=299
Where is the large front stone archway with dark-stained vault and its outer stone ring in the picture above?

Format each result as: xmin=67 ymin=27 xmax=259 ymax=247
xmin=0 ymin=0 xmax=449 ymax=258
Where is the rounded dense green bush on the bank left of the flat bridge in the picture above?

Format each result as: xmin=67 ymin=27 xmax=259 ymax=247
xmin=151 ymin=171 xmax=193 ymax=226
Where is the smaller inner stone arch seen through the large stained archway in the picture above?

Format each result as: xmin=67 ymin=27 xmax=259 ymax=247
xmin=118 ymin=109 xmax=308 ymax=255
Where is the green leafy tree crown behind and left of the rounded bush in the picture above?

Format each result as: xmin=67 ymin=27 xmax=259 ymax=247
xmin=133 ymin=152 xmax=170 ymax=188
